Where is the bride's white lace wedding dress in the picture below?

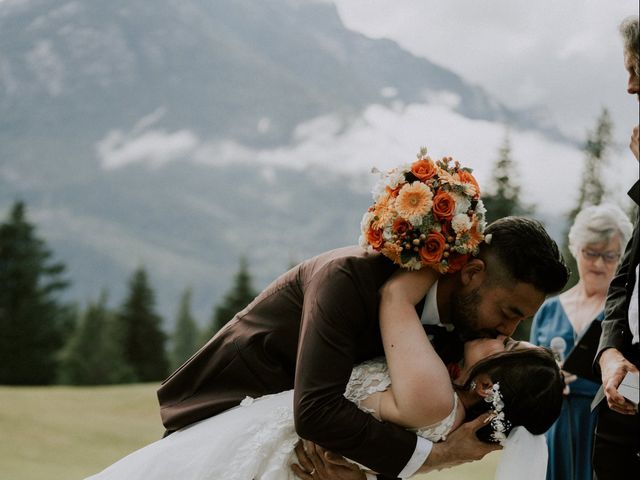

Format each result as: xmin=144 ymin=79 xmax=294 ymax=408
xmin=89 ymin=358 xmax=458 ymax=480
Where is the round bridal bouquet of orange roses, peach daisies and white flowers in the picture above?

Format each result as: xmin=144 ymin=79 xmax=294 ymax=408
xmin=360 ymin=148 xmax=486 ymax=273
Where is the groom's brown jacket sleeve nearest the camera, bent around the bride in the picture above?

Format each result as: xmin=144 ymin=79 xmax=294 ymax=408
xmin=294 ymin=265 xmax=416 ymax=478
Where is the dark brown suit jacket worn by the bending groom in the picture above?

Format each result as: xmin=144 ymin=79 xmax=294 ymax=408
xmin=158 ymin=247 xmax=416 ymax=476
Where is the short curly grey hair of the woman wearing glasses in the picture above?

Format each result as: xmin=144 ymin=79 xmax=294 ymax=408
xmin=569 ymin=203 xmax=633 ymax=258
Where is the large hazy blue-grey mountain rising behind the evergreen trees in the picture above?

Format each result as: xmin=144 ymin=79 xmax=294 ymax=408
xmin=0 ymin=0 xmax=558 ymax=321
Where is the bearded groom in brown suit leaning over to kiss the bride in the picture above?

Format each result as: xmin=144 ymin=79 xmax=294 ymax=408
xmin=158 ymin=217 xmax=567 ymax=478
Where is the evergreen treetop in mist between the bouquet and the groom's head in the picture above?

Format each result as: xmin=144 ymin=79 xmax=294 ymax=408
xmin=482 ymin=134 xmax=533 ymax=222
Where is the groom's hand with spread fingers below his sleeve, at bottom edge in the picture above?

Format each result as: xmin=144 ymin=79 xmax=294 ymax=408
xmin=291 ymin=440 xmax=366 ymax=480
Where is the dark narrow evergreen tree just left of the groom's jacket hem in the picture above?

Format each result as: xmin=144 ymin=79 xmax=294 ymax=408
xmin=116 ymin=268 xmax=169 ymax=382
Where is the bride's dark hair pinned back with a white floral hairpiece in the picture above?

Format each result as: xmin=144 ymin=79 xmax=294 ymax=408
xmin=462 ymin=347 xmax=565 ymax=442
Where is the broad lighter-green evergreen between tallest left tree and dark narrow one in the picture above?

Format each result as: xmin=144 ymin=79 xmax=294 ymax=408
xmin=59 ymin=293 xmax=135 ymax=385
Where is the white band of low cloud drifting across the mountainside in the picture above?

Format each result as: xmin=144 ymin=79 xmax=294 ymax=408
xmin=97 ymin=105 xmax=637 ymax=214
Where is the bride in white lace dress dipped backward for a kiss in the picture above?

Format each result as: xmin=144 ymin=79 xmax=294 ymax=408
xmin=89 ymin=269 xmax=564 ymax=480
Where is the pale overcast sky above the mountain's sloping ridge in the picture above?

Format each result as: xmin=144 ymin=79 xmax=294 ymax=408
xmin=335 ymin=0 xmax=638 ymax=146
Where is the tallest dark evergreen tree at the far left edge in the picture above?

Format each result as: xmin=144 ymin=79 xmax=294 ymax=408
xmin=0 ymin=202 xmax=68 ymax=385
